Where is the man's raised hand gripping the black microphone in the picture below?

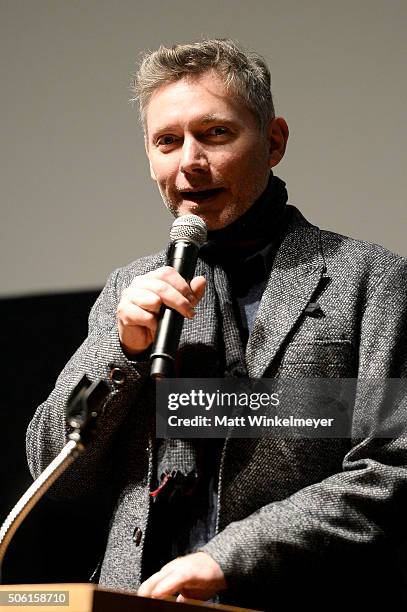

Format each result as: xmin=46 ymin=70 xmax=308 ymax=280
xmin=117 ymin=266 xmax=206 ymax=355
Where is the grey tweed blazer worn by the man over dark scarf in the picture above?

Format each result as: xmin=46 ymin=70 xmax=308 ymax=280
xmin=27 ymin=210 xmax=407 ymax=609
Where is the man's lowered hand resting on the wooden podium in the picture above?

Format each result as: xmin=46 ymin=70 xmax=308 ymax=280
xmin=137 ymin=552 xmax=227 ymax=601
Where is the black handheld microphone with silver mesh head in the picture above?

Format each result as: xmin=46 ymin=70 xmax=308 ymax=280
xmin=150 ymin=215 xmax=207 ymax=378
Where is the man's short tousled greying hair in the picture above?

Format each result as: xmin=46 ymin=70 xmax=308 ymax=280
xmin=131 ymin=38 xmax=275 ymax=129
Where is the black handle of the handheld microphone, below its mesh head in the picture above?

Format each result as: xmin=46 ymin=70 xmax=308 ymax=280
xmin=150 ymin=239 xmax=199 ymax=378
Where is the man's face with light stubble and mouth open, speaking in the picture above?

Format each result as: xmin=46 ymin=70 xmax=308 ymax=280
xmin=146 ymin=71 xmax=285 ymax=230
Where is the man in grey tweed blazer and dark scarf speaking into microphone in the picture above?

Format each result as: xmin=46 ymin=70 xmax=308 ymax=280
xmin=27 ymin=40 xmax=407 ymax=609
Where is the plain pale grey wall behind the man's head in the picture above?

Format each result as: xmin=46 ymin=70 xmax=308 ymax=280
xmin=0 ymin=0 xmax=407 ymax=296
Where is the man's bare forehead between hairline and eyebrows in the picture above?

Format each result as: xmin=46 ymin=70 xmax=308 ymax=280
xmin=146 ymin=70 xmax=251 ymax=132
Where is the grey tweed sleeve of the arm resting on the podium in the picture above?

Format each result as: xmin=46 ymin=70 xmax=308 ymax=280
xmin=201 ymin=258 xmax=407 ymax=589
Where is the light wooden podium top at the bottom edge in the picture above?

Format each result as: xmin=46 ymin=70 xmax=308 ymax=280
xmin=0 ymin=583 xmax=258 ymax=612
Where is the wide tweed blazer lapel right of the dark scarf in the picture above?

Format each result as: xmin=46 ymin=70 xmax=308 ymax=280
xmin=246 ymin=211 xmax=325 ymax=378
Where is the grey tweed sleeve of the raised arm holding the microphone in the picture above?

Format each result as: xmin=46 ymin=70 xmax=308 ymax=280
xmin=26 ymin=270 xmax=152 ymax=498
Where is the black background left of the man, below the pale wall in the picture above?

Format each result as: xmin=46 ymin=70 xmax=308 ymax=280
xmin=0 ymin=290 xmax=113 ymax=584
